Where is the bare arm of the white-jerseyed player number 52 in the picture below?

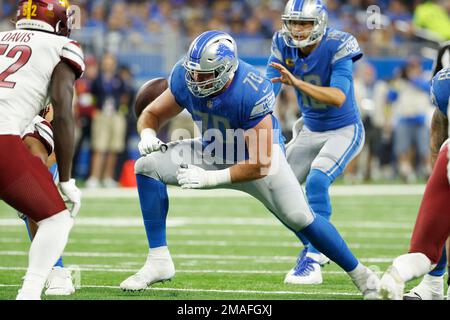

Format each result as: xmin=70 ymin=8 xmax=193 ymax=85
xmin=51 ymin=62 xmax=76 ymax=182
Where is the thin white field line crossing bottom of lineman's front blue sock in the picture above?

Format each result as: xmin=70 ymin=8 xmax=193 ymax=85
xmin=0 ymin=238 xmax=408 ymax=250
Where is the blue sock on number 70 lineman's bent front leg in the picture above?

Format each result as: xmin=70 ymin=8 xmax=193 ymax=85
xmin=136 ymin=174 xmax=169 ymax=249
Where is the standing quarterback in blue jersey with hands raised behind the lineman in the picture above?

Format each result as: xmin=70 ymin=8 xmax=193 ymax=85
xmin=267 ymin=0 xmax=364 ymax=284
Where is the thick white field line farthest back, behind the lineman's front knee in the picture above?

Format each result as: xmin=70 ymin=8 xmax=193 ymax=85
xmin=82 ymin=184 xmax=425 ymax=199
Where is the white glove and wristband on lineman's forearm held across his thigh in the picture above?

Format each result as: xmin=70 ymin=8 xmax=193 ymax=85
xmin=177 ymin=165 xmax=231 ymax=189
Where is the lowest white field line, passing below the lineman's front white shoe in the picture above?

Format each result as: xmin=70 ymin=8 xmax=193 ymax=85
xmin=0 ymin=284 xmax=361 ymax=297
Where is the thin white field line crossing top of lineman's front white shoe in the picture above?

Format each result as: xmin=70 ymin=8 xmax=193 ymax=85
xmin=0 ymin=251 xmax=395 ymax=263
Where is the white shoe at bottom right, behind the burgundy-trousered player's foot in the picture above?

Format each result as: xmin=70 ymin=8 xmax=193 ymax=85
xmin=403 ymin=274 xmax=444 ymax=300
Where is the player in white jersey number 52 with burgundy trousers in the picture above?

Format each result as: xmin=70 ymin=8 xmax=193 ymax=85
xmin=0 ymin=0 xmax=84 ymax=300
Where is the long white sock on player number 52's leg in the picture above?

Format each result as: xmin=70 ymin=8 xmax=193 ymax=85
xmin=22 ymin=210 xmax=73 ymax=296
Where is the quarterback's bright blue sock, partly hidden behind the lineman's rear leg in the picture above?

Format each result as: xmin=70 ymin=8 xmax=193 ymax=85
xmin=299 ymin=169 xmax=332 ymax=254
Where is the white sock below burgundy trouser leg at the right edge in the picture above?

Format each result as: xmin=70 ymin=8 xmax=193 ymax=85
xmin=393 ymin=253 xmax=432 ymax=282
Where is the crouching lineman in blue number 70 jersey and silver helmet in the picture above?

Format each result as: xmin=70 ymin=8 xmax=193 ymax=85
xmin=120 ymin=31 xmax=378 ymax=298
